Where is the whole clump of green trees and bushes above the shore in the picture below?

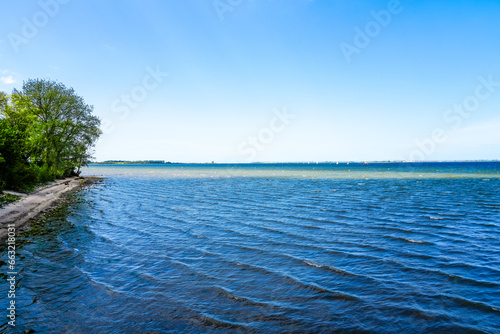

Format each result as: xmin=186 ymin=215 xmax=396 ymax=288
xmin=0 ymin=79 xmax=101 ymax=190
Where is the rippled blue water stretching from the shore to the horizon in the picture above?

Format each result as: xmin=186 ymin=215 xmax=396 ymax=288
xmin=0 ymin=163 xmax=500 ymax=333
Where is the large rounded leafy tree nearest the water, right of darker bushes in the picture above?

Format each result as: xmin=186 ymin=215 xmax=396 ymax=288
xmin=12 ymin=79 xmax=101 ymax=176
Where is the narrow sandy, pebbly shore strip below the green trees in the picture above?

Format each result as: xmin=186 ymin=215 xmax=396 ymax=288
xmin=0 ymin=176 xmax=102 ymax=240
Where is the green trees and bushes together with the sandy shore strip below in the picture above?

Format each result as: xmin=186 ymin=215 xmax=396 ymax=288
xmin=0 ymin=79 xmax=102 ymax=239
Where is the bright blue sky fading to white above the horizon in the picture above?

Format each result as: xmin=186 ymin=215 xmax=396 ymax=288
xmin=0 ymin=0 xmax=500 ymax=162
